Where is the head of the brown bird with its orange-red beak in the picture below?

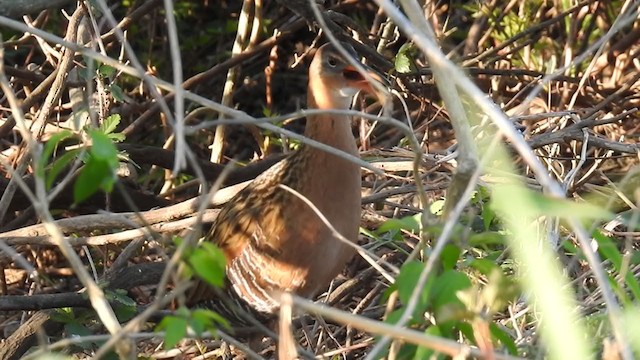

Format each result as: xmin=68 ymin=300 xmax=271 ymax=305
xmin=308 ymin=43 xmax=383 ymax=109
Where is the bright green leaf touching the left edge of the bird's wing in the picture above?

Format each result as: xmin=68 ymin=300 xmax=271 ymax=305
xmin=188 ymin=242 xmax=227 ymax=287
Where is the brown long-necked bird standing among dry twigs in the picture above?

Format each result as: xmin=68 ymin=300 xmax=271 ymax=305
xmin=187 ymin=43 xmax=383 ymax=324
